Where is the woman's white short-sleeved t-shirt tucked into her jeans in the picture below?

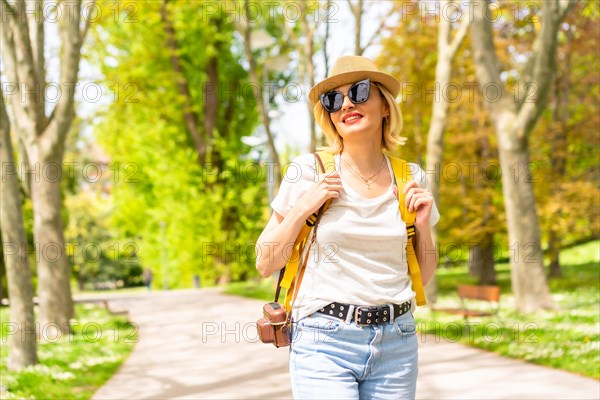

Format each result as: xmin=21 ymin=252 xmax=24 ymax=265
xmin=271 ymin=154 xmax=440 ymax=321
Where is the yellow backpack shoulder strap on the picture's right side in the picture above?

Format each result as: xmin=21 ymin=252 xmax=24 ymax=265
xmin=388 ymin=155 xmax=426 ymax=306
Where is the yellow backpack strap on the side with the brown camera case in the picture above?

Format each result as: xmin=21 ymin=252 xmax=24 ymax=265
xmin=280 ymin=151 xmax=335 ymax=312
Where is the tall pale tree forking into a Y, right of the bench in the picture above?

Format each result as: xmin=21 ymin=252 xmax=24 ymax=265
xmin=471 ymin=0 xmax=573 ymax=312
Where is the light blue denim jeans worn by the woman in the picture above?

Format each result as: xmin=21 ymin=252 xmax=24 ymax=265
xmin=290 ymin=312 xmax=418 ymax=400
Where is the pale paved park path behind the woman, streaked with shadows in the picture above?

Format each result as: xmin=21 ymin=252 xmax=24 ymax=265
xmin=94 ymin=289 xmax=600 ymax=400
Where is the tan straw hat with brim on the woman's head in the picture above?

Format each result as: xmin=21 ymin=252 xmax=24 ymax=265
xmin=308 ymin=56 xmax=400 ymax=104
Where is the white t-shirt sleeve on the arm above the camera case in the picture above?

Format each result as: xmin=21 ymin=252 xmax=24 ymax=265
xmin=271 ymin=154 xmax=318 ymax=217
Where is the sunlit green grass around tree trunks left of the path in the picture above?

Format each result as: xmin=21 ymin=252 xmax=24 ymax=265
xmin=0 ymin=304 xmax=137 ymax=399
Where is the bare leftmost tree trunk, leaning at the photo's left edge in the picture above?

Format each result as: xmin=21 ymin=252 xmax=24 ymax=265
xmin=0 ymin=91 xmax=37 ymax=370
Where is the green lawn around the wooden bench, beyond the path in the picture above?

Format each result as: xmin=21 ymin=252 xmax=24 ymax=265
xmin=227 ymin=241 xmax=600 ymax=379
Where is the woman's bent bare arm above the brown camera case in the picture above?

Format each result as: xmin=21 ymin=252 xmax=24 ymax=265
xmin=256 ymin=171 xmax=342 ymax=277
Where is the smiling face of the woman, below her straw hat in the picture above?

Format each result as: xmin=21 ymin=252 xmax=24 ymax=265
xmin=329 ymin=84 xmax=389 ymax=141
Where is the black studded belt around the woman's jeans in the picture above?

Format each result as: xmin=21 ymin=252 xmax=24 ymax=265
xmin=317 ymin=301 xmax=411 ymax=326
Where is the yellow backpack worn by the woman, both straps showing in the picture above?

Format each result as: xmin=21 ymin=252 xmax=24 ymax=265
xmin=275 ymin=151 xmax=426 ymax=312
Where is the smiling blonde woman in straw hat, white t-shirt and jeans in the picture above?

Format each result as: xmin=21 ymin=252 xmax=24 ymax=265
xmin=257 ymin=56 xmax=439 ymax=400
